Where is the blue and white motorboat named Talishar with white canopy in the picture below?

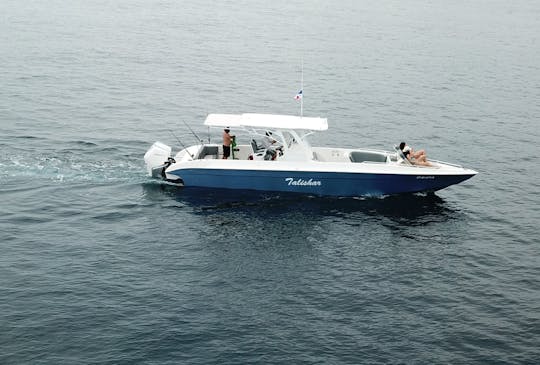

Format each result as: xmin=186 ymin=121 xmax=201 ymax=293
xmin=144 ymin=114 xmax=477 ymax=197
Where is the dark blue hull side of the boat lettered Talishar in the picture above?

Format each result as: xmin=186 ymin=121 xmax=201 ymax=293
xmin=170 ymin=168 xmax=474 ymax=197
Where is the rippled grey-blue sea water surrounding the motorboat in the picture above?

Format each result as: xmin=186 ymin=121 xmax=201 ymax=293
xmin=0 ymin=0 xmax=540 ymax=364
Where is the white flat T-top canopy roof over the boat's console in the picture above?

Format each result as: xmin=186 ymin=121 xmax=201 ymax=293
xmin=204 ymin=113 xmax=328 ymax=131
